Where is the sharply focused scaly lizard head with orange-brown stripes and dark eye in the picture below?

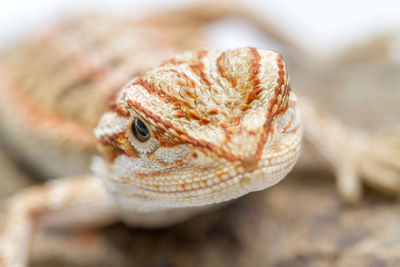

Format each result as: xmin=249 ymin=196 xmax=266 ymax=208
xmin=95 ymin=48 xmax=301 ymax=209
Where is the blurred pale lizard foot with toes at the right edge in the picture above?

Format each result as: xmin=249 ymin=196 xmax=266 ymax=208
xmin=333 ymin=128 xmax=400 ymax=204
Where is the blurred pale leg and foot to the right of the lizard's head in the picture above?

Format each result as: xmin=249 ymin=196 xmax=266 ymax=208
xmin=300 ymin=98 xmax=400 ymax=203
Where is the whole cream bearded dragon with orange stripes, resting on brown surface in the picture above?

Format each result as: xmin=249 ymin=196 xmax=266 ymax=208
xmin=0 ymin=4 xmax=398 ymax=266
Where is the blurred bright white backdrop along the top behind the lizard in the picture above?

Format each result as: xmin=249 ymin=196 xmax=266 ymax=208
xmin=0 ymin=0 xmax=400 ymax=56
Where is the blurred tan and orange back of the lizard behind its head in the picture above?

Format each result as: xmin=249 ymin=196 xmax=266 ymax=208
xmin=0 ymin=14 xmax=201 ymax=177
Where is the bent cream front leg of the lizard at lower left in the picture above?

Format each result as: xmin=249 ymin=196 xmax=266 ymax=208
xmin=0 ymin=175 xmax=118 ymax=267
